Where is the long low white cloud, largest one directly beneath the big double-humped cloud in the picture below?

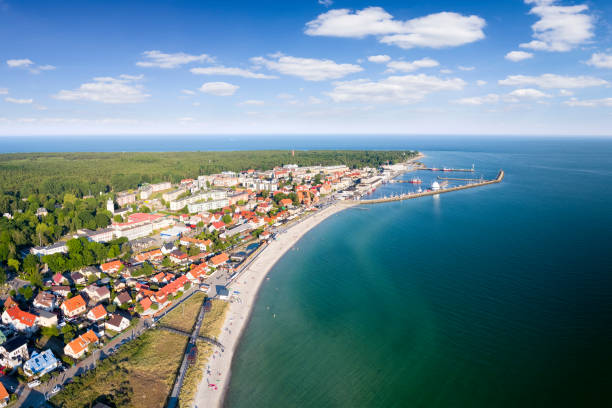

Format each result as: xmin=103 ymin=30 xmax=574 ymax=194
xmin=327 ymin=74 xmax=465 ymax=103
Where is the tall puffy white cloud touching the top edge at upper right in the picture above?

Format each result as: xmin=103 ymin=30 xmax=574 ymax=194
xmin=520 ymin=0 xmax=593 ymax=52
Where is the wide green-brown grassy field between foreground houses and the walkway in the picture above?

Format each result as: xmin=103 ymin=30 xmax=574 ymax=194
xmin=51 ymin=330 xmax=187 ymax=408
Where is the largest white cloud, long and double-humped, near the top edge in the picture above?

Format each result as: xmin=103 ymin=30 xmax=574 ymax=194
xmin=305 ymin=7 xmax=486 ymax=49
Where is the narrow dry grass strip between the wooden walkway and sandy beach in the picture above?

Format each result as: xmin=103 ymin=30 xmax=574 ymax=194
xmin=179 ymin=299 xmax=229 ymax=407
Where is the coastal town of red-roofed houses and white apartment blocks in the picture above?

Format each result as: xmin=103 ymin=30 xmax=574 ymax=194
xmin=0 ymin=161 xmax=416 ymax=406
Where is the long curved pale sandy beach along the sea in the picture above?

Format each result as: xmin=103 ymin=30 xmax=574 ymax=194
xmin=193 ymin=204 xmax=348 ymax=408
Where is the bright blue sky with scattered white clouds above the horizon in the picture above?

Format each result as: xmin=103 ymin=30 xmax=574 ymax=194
xmin=0 ymin=0 xmax=612 ymax=135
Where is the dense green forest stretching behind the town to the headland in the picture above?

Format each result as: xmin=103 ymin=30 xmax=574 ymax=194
xmin=0 ymin=150 xmax=417 ymax=283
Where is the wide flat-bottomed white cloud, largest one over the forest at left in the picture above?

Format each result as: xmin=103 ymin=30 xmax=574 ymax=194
xmin=54 ymin=75 xmax=151 ymax=104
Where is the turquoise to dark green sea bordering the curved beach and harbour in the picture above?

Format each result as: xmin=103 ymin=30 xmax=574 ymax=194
xmin=225 ymin=139 xmax=612 ymax=408
